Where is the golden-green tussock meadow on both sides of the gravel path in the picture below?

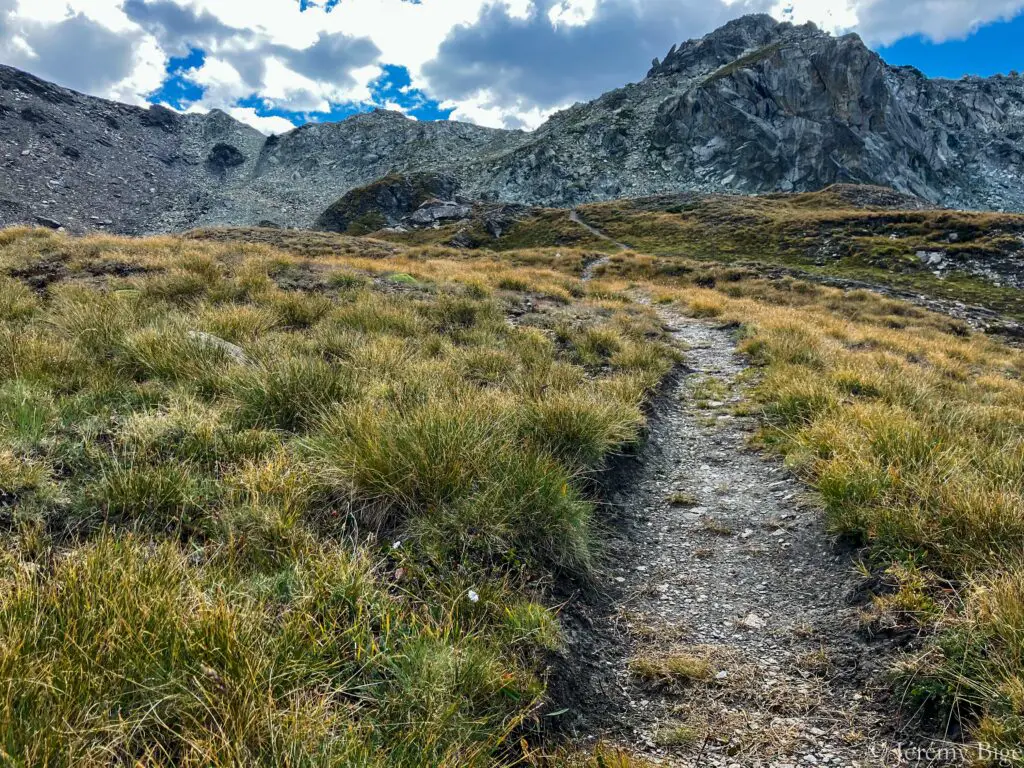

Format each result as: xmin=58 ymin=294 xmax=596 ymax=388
xmin=0 ymin=221 xmax=1024 ymax=766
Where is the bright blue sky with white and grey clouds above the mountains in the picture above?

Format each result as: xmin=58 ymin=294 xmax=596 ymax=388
xmin=0 ymin=0 xmax=1024 ymax=133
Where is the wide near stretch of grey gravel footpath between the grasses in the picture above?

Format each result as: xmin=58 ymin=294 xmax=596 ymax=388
xmin=569 ymin=314 xmax=894 ymax=766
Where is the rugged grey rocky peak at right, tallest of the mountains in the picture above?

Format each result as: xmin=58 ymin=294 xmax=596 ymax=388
xmin=468 ymin=16 xmax=1024 ymax=210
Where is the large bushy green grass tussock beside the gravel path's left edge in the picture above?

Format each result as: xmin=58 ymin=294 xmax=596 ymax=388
xmin=314 ymin=395 xmax=591 ymax=571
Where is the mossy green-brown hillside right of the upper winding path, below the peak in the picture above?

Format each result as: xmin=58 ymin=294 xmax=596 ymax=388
xmin=580 ymin=187 xmax=1024 ymax=321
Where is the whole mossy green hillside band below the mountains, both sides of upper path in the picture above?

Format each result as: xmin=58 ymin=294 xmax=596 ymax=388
xmin=364 ymin=185 xmax=1024 ymax=323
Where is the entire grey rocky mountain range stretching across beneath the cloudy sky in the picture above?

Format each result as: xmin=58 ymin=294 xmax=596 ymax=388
xmin=0 ymin=15 xmax=1024 ymax=233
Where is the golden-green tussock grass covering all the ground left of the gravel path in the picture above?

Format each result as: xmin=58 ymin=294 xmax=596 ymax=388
xmin=0 ymin=229 xmax=674 ymax=767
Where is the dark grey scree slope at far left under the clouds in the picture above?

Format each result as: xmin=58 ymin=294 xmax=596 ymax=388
xmin=0 ymin=67 xmax=265 ymax=233
